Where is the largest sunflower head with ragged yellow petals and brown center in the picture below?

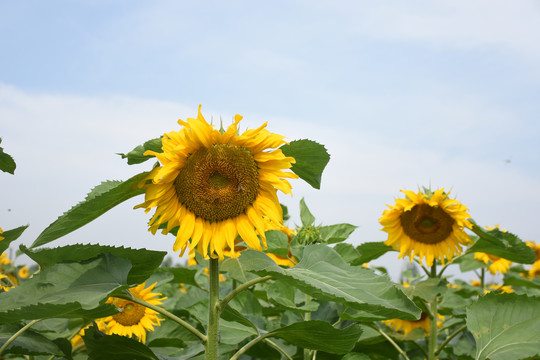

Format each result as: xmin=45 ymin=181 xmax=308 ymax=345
xmin=136 ymin=106 xmax=298 ymax=259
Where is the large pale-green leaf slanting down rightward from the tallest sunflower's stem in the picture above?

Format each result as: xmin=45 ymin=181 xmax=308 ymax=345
xmin=240 ymin=244 xmax=421 ymax=320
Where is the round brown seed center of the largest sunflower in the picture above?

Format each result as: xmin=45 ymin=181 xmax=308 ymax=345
xmin=174 ymin=144 xmax=259 ymax=221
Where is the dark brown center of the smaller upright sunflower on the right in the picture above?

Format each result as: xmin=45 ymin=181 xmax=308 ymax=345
xmin=400 ymin=204 xmax=454 ymax=244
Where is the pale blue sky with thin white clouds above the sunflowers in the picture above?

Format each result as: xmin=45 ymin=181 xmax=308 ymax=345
xmin=0 ymin=0 xmax=540 ymax=277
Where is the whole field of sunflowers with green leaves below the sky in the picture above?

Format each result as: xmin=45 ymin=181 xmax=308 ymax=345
xmin=0 ymin=107 xmax=540 ymax=360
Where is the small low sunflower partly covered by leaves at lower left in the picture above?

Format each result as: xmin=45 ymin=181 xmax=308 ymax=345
xmin=103 ymin=283 xmax=166 ymax=343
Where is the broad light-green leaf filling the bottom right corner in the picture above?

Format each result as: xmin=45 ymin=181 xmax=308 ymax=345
xmin=467 ymin=294 xmax=540 ymax=360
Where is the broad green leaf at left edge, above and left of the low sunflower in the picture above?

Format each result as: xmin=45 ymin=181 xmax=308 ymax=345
xmin=0 ymin=254 xmax=131 ymax=322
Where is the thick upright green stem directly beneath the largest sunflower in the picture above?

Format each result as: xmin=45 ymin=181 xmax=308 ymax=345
xmin=205 ymin=258 xmax=219 ymax=360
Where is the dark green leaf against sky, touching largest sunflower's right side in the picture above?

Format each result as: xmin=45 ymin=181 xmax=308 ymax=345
xmin=280 ymin=139 xmax=330 ymax=189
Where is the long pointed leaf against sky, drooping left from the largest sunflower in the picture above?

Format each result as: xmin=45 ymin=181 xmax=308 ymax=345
xmin=30 ymin=172 xmax=148 ymax=248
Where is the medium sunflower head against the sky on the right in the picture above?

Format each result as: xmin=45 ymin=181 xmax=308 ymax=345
xmin=379 ymin=189 xmax=472 ymax=266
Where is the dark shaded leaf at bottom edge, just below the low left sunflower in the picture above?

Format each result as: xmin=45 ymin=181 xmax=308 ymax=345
xmin=83 ymin=326 xmax=159 ymax=360
